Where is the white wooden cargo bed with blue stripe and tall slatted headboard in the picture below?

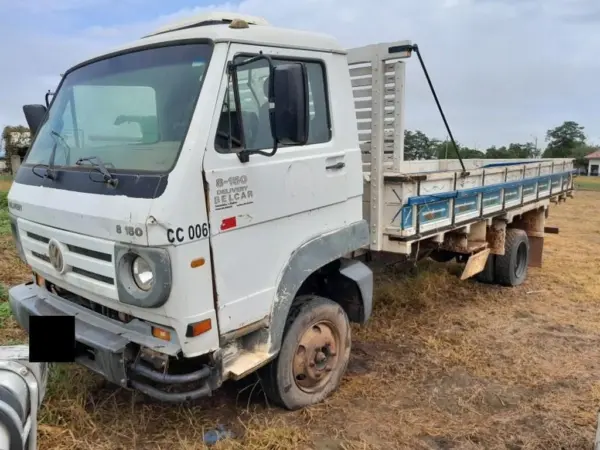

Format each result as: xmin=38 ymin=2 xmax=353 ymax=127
xmin=348 ymin=41 xmax=574 ymax=254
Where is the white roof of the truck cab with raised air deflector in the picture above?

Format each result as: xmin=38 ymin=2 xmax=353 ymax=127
xmin=85 ymin=12 xmax=346 ymax=64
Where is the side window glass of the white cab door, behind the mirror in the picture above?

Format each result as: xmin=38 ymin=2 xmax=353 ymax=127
xmin=215 ymin=56 xmax=331 ymax=153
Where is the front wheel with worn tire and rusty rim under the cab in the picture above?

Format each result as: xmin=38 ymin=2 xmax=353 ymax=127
xmin=261 ymin=295 xmax=351 ymax=410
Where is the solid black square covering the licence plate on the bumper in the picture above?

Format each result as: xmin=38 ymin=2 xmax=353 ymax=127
xmin=29 ymin=316 xmax=75 ymax=363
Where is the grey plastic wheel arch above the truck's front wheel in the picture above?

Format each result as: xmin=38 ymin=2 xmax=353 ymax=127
xmin=269 ymin=220 xmax=373 ymax=353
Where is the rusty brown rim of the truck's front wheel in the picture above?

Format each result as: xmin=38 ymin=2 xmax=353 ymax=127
xmin=293 ymin=321 xmax=340 ymax=393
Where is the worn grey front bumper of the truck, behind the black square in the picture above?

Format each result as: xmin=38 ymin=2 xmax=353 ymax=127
xmin=9 ymin=283 xmax=215 ymax=402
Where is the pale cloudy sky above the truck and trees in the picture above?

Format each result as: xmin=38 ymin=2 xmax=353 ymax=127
xmin=0 ymin=0 xmax=600 ymax=149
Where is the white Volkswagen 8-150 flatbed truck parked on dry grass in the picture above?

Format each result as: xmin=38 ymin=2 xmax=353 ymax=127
xmin=9 ymin=13 xmax=573 ymax=409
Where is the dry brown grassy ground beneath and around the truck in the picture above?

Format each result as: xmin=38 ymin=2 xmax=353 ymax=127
xmin=0 ymin=187 xmax=600 ymax=450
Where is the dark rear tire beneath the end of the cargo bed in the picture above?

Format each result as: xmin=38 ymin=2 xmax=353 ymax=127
xmin=494 ymin=228 xmax=529 ymax=286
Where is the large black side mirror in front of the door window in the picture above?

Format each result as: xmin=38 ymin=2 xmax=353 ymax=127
xmin=271 ymin=63 xmax=310 ymax=145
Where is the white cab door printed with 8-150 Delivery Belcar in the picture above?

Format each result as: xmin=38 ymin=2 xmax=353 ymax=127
xmin=204 ymin=44 xmax=352 ymax=334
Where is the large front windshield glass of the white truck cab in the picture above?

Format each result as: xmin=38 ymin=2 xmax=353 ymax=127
xmin=25 ymin=44 xmax=212 ymax=172
